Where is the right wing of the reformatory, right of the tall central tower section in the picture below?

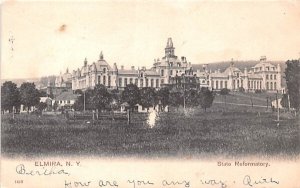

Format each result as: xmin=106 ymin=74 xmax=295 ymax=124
xmin=197 ymin=56 xmax=282 ymax=92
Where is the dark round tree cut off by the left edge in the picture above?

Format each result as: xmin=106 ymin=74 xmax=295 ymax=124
xmin=1 ymin=81 xmax=21 ymax=112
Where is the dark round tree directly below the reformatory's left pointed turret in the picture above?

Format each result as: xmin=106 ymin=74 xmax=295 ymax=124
xmin=90 ymin=84 xmax=112 ymax=112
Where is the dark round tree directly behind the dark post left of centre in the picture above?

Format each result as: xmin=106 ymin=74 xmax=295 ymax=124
xmin=122 ymin=84 xmax=141 ymax=109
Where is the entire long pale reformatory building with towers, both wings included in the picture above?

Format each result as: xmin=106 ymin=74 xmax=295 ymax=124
xmin=64 ymin=38 xmax=281 ymax=91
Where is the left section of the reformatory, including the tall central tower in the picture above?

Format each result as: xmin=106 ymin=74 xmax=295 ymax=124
xmin=72 ymin=38 xmax=191 ymax=90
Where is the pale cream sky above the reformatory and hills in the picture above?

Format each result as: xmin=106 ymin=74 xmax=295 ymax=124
xmin=1 ymin=0 xmax=300 ymax=79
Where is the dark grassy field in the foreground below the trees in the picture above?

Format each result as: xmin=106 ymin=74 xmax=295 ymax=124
xmin=1 ymin=107 xmax=300 ymax=157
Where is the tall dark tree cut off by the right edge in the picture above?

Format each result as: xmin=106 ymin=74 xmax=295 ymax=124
xmin=285 ymin=60 xmax=300 ymax=111
